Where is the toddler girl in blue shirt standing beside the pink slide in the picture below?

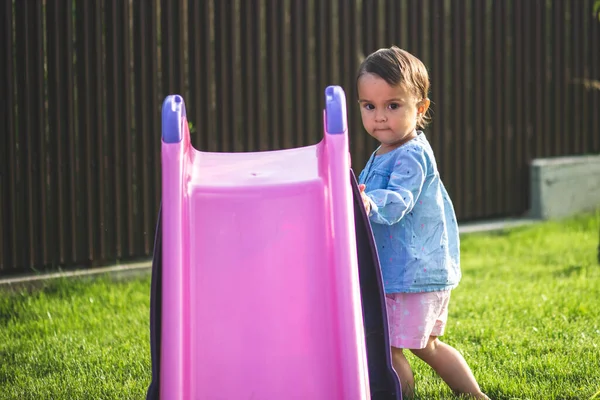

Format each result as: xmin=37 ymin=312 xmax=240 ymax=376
xmin=357 ymin=46 xmax=488 ymax=399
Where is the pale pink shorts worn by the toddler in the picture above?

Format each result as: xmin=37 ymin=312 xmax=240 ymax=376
xmin=385 ymin=290 xmax=450 ymax=349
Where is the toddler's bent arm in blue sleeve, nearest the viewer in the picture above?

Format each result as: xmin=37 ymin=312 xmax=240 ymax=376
xmin=366 ymin=151 xmax=427 ymax=225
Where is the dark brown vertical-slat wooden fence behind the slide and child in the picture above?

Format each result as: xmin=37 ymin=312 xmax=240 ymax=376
xmin=0 ymin=0 xmax=600 ymax=275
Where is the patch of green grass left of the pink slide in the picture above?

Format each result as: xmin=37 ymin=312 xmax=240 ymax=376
xmin=0 ymin=278 xmax=151 ymax=400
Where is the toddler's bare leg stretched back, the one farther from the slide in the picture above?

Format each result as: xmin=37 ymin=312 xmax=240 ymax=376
xmin=411 ymin=336 xmax=489 ymax=399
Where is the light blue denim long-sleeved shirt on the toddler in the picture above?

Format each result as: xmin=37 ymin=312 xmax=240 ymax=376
xmin=358 ymin=132 xmax=461 ymax=293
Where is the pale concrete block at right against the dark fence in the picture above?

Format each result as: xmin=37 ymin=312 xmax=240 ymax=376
xmin=530 ymin=155 xmax=600 ymax=219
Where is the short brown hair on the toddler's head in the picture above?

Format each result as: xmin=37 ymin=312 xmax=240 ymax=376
xmin=356 ymin=46 xmax=429 ymax=128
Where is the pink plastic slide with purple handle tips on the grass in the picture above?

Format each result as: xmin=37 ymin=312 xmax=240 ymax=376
xmin=148 ymin=86 xmax=400 ymax=400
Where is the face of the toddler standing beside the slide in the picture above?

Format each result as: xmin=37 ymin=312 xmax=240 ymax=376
xmin=358 ymin=74 xmax=429 ymax=152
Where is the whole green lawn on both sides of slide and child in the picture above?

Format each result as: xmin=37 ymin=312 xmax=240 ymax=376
xmin=0 ymin=214 xmax=600 ymax=399
